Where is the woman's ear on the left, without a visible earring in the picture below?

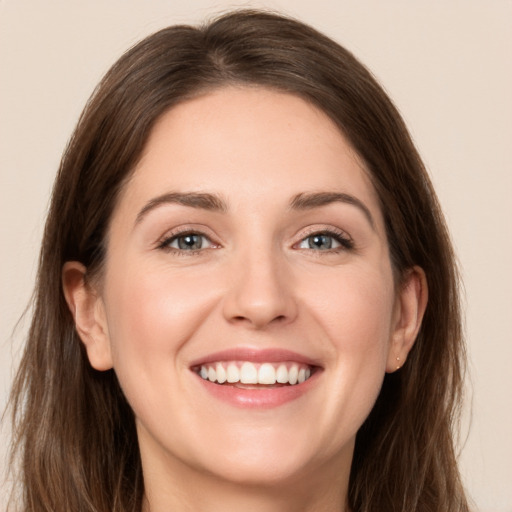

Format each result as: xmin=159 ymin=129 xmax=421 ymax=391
xmin=62 ymin=261 xmax=112 ymax=371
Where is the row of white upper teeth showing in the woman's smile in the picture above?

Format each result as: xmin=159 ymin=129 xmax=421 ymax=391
xmin=198 ymin=361 xmax=311 ymax=386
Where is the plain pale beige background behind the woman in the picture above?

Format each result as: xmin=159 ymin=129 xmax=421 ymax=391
xmin=0 ymin=0 xmax=512 ymax=512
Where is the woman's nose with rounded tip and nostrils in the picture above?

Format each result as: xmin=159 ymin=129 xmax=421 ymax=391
xmin=223 ymin=253 xmax=297 ymax=329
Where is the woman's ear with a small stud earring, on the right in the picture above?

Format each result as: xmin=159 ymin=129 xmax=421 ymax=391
xmin=386 ymin=267 xmax=428 ymax=373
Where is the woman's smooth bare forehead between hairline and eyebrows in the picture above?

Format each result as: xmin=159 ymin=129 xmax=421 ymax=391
xmin=114 ymin=87 xmax=380 ymax=227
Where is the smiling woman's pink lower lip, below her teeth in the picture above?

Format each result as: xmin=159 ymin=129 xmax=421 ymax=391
xmin=195 ymin=371 xmax=321 ymax=409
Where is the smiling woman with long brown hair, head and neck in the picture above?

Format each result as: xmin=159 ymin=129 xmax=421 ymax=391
xmin=8 ymin=11 xmax=468 ymax=512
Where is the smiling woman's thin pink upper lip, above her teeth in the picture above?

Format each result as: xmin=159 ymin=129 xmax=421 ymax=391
xmin=190 ymin=347 xmax=320 ymax=367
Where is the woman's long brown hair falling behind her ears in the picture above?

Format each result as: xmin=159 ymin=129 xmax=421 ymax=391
xmin=11 ymin=11 xmax=467 ymax=512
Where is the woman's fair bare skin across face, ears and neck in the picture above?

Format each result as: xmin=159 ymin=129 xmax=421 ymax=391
xmin=63 ymin=88 xmax=427 ymax=512
